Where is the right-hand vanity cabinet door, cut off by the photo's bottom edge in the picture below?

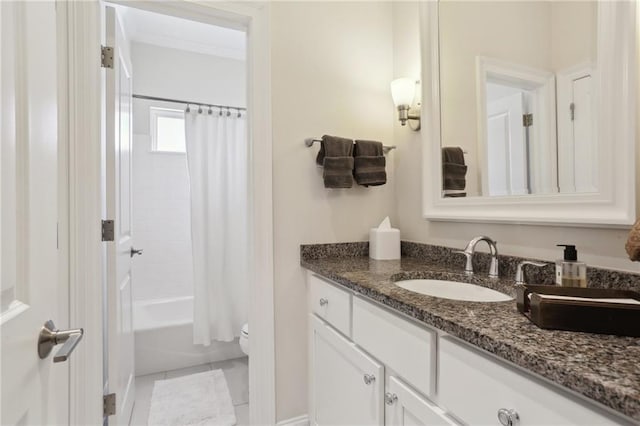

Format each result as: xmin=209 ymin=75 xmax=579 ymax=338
xmin=385 ymin=376 xmax=456 ymax=426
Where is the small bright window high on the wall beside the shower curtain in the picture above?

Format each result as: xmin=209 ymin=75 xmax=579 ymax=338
xmin=149 ymin=108 xmax=187 ymax=153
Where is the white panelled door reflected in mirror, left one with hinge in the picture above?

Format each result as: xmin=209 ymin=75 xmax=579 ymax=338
xmin=487 ymin=92 xmax=529 ymax=195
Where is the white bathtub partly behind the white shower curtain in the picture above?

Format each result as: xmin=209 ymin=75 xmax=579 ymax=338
xmin=133 ymin=297 xmax=244 ymax=376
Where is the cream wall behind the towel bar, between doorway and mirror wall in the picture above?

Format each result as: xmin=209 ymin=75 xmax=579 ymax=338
xmin=271 ymin=2 xmax=396 ymax=420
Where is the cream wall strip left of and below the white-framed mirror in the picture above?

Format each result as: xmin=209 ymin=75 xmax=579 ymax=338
xmin=394 ymin=2 xmax=640 ymax=280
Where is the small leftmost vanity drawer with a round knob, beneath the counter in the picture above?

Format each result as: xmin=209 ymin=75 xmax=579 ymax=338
xmin=307 ymin=273 xmax=351 ymax=337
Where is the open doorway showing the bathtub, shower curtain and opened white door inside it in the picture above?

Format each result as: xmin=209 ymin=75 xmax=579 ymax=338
xmin=104 ymin=6 xmax=249 ymax=424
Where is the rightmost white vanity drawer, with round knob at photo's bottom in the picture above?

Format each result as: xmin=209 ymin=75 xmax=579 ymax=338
xmin=438 ymin=337 xmax=627 ymax=426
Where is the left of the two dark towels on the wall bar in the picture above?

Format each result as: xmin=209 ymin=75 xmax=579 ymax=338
xmin=316 ymin=135 xmax=353 ymax=188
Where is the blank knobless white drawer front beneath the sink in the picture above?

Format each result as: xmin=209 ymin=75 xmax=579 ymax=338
xmin=353 ymin=297 xmax=436 ymax=397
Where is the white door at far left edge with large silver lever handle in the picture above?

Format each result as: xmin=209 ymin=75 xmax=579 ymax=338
xmin=0 ymin=2 xmax=71 ymax=425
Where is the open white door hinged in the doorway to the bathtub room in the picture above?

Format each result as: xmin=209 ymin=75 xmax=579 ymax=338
xmin=105 ymin=7 xmax=135 ymax=425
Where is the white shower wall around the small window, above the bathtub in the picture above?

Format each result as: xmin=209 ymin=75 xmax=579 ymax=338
xmin=132 ymin=43 xmax=245 ymax=300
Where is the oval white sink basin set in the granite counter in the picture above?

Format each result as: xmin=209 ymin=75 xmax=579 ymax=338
xmin=396 ymin=279 xmax=512 ymax=302
